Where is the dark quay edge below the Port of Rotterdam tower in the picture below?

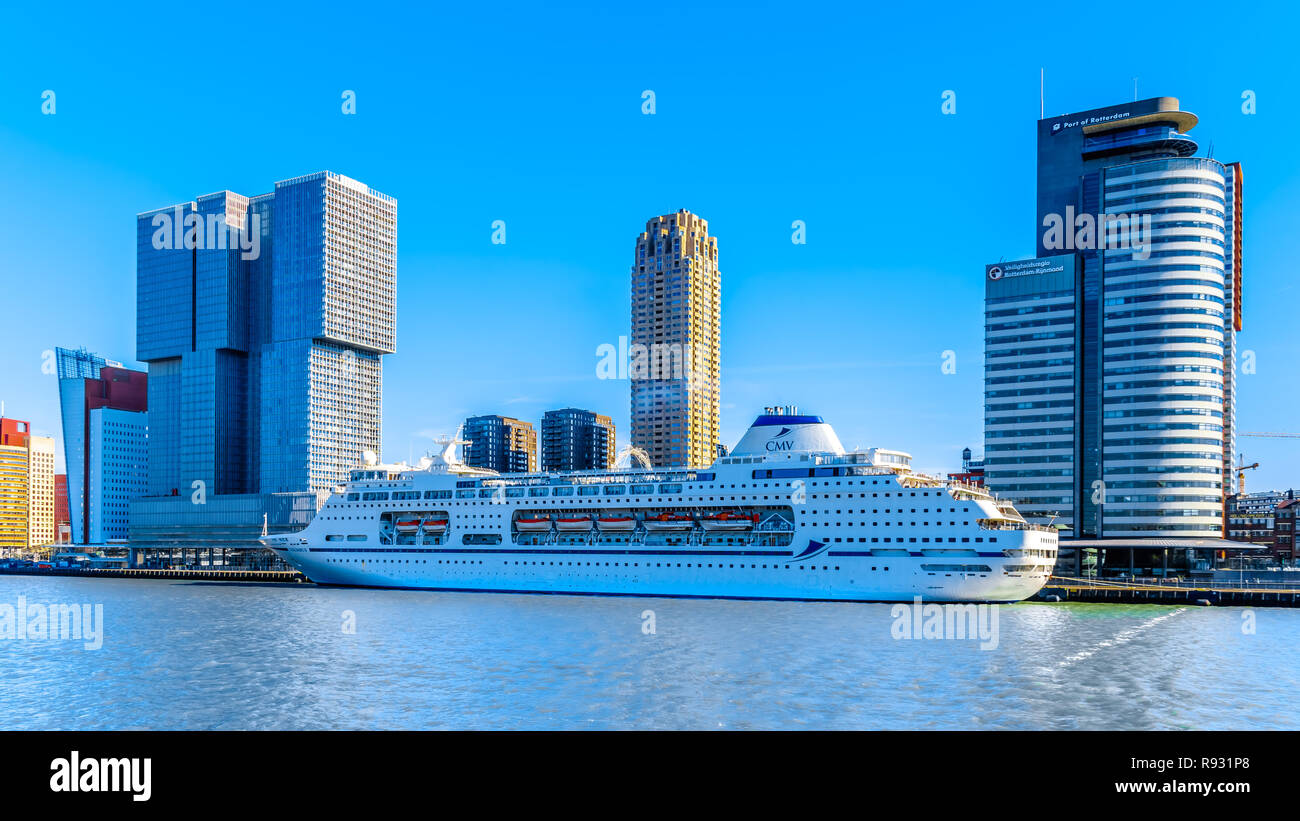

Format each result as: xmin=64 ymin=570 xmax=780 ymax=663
xmin=1030 ymin=575 xmax=1300 ymax=607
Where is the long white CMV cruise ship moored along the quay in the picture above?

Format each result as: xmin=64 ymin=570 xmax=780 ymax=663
xmin=261 ymin=408 xmax=1057 ymax=601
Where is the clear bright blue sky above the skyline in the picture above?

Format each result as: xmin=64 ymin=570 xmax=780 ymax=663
xmin=0 ymin=3 xmax=1300 ymax=490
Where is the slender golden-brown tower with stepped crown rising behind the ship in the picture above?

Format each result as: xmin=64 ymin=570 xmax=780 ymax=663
xmin=628 ymin=210 xmax=722 ymax=468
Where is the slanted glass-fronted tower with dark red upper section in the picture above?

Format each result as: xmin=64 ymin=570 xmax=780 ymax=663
xmin=55 ymin=348 xmax=148 ymax=544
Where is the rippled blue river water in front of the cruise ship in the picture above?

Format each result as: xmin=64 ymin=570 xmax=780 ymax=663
xmin=0 ymin=575 xmax=1300 ymax=729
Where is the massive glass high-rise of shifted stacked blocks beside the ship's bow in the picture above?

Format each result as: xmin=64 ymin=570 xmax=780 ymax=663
xmin=131 ymin=171 xmax=397 ymax=561
